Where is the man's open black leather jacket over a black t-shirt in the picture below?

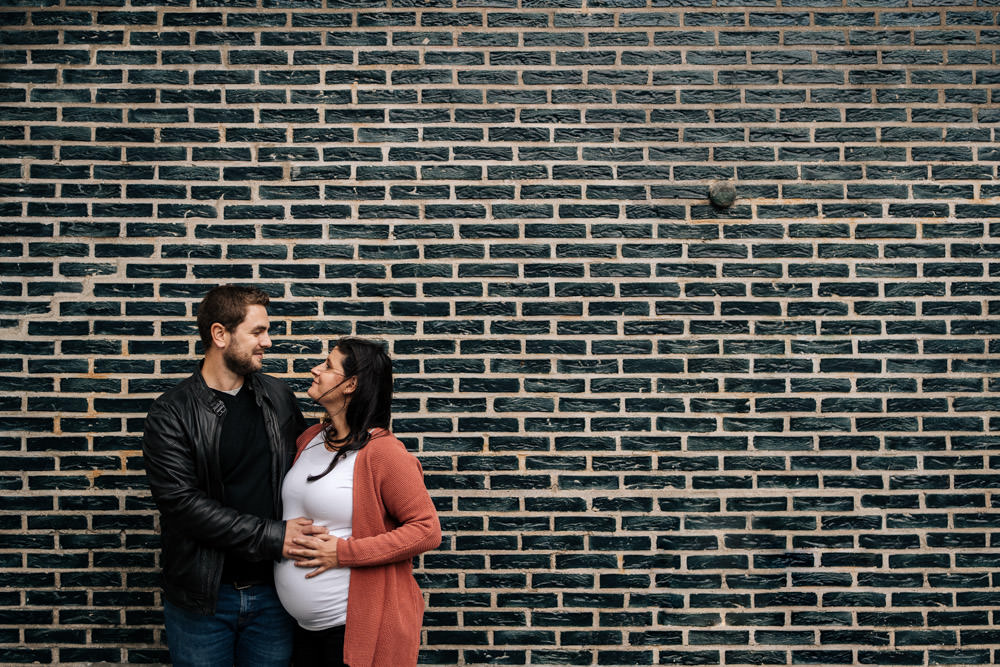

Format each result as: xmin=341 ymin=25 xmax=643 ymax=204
xmin=142 ymin=369 xmax=305 ymax=614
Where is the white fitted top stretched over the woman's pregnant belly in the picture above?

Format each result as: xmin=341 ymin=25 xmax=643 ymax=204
xmin=274 ymin=431 xmax=358 ymax=630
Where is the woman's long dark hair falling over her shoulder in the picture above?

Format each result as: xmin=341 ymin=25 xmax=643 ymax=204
xmin=306 ymin=338 xmax=392 ymax=482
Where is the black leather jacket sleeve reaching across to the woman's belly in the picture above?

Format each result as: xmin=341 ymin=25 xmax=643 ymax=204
xmin=142 ymin=403 xmax=285 ymax=560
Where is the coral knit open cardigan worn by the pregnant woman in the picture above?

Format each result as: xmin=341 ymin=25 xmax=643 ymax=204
xmin=296 ymin=424 xmax=441 ymax=667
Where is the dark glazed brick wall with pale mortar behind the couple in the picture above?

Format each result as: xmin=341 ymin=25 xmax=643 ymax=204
xmin=0 ymin=0 xmax=1000 ymax=665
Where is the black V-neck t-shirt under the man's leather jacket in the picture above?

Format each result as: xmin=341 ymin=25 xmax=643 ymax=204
xmin=214 ymin=383 xmax=278 ymax=583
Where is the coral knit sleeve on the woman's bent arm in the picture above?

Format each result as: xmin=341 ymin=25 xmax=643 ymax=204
xmin=337 ymin=446 xmax=441 ymax=567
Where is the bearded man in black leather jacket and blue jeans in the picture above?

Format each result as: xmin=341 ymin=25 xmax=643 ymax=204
xmin=142 ymin=285 xmax=321 ymax=667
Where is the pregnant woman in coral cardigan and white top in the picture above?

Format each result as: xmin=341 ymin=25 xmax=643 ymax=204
xmin=274 ymin=338 xmax=441 ymax=667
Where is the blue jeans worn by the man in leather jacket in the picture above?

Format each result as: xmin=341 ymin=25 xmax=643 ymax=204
xmin=163 ymin=584 xmax=295 ymax=667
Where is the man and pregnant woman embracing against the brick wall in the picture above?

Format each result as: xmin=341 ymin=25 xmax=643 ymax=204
xmin=143 ymin=285 xmax=441 ymax=667
